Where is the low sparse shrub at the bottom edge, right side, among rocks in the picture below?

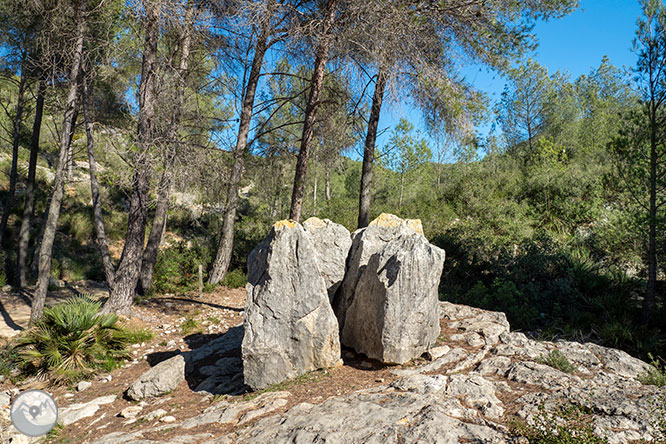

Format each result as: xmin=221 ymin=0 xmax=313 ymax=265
xmin=511 ymin=405 xmax=608 ymax=444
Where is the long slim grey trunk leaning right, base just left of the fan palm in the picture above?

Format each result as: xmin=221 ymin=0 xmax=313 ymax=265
xmin=30 ymin=7 xmax=86 ymax=323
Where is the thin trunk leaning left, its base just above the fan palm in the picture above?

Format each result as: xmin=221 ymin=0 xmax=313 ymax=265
xmin=82 ymin=80 xmax=115 ymax=289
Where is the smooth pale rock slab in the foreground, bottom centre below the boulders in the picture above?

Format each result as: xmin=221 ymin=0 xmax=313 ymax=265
xmin=226 ymin=375 xmax=511 ymax=444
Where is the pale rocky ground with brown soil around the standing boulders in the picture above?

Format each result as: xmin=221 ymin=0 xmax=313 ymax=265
xmin=0 ymin=289 xmax=666 ymax=444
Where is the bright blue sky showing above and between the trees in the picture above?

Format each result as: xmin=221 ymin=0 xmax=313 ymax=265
xmin=377 ymin=0 xmax=640 ymax=153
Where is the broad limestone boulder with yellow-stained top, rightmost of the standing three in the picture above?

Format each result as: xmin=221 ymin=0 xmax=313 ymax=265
xmin=335 ymin=214 xmax=444 ymax=364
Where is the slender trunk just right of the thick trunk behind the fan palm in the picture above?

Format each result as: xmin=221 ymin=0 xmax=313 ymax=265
xmin=138 ymin=3 xmax=194 ymax=294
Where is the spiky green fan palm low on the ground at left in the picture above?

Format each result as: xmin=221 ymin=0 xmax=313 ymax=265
xmin=18 ymin=296 xmax=129 ymax=383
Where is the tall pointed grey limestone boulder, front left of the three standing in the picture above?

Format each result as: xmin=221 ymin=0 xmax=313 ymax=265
xmin=241 ymin=221 xmax=340 ymax=389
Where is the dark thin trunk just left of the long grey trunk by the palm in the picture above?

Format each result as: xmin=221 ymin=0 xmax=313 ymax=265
xmin=16 ymin=78 xmax=46 ymax=288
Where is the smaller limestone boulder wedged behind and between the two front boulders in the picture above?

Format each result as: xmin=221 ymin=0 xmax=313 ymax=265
xmin=303 ymin=217 xmax=351 ymax=300
